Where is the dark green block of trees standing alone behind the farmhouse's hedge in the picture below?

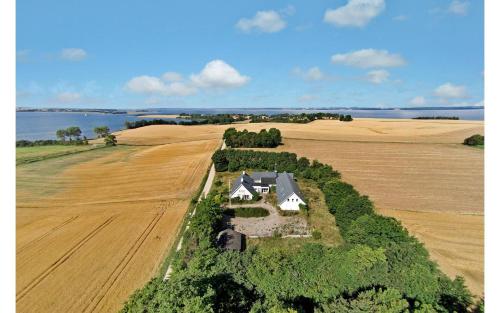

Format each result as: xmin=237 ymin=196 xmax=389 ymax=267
xmin=223 ymin=127 xmax=282 ymax=148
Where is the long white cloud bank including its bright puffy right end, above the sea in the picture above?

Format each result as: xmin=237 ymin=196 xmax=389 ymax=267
xmin=124 ymin=60 xmax=250 ymax=96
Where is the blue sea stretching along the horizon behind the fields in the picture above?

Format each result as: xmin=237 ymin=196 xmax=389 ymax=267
xmin=16 ymin=108 xmax=484 ymax=140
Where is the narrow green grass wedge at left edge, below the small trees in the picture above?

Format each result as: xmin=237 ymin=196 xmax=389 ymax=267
xmin=16 ymin=145 xmax=102 ymax=165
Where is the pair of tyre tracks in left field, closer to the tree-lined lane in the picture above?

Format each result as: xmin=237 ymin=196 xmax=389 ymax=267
xmin=83 ymin=200 xmax=169 ymax=312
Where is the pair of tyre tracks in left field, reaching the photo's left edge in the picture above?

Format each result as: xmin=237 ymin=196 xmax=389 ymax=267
xmin=16 ymin=215 xmax=116 ymax=302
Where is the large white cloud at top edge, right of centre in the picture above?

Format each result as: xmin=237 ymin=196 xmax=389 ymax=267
xmin=323 ymin=0 xmax=385 ymax=27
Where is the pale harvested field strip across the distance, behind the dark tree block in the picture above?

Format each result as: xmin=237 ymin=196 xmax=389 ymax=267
xmin=116 ymin=119 xmax=483 ymax=145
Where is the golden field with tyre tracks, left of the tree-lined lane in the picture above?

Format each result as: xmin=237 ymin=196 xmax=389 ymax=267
xmin=16 ymin=138 xmax=220 ymax=312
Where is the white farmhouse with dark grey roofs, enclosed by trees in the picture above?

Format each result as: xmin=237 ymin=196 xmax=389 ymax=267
xmin=229 ymin=172 xmax=306 ymax=211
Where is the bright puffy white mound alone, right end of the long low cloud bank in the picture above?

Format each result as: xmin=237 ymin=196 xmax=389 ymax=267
xmin=190 ymin=60 xmax=250 ymax=89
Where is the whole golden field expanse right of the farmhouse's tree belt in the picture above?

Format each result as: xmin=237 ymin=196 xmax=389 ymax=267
xmin=250 ymin=119 xmax=484 ymax=296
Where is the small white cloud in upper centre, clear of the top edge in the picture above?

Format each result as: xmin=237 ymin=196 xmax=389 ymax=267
xmin=236 ymin=10 xmax=286 ymax=33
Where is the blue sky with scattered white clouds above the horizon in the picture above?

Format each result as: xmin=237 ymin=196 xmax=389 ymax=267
xmin=16 ymin=0 xmax=484 ymax=109
